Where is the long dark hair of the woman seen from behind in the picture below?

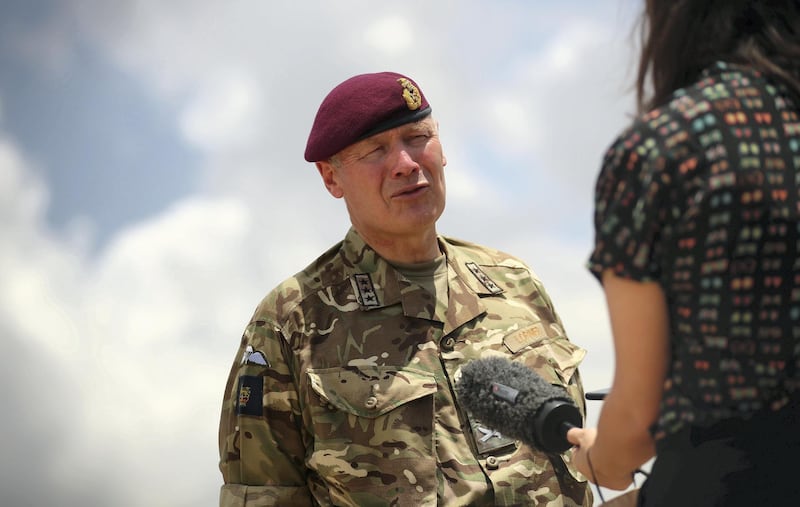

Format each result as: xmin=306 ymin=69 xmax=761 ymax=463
xmin=636 ymin=0 xmax=800 ymax=112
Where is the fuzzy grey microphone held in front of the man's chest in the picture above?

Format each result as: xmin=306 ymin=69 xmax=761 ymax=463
xmin=455 ymin=357 xmax=582 ymax=454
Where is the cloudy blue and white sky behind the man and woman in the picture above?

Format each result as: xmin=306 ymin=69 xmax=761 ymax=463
xmin=0 ymin=0 xmax=640 ymax=507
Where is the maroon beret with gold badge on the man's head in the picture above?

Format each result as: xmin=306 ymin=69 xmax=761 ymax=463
xmin=305 ymin=72 xmax=431 ymax=162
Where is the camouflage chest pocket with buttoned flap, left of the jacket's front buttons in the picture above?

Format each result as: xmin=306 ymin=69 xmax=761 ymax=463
xmin=306 ymin=366 xmax=437 ymax=505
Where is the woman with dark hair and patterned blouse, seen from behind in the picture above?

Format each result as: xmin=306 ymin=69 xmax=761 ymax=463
xmin=569 ymin=0 xmax=800 ymax=506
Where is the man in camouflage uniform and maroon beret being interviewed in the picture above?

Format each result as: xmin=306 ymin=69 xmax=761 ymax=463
xmin=219 ymin=72 xmax=592 ymax=507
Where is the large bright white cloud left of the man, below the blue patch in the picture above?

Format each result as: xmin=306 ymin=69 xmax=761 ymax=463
xmin=0 ymin=132 xmax=257 ymax=506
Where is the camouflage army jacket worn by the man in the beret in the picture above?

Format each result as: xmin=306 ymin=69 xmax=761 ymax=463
xmin=219 ymin=229 xmax=592 ymax=507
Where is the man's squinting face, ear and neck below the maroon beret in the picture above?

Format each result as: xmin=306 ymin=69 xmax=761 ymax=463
xmin=317 ymin=117 xmax=447 ymax=240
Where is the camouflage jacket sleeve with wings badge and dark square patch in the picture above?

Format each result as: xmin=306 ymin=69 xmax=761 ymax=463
xmin=219 ymin=318 xmax=312 ymax=507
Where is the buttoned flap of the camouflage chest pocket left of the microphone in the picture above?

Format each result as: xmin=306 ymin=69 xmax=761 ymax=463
xmin=306 ymin=366 xmax=436 ymax=419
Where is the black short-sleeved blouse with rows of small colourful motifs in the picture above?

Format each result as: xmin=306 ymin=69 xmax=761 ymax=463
xmin=588 ymin=62 xmax=800 ymax=438
